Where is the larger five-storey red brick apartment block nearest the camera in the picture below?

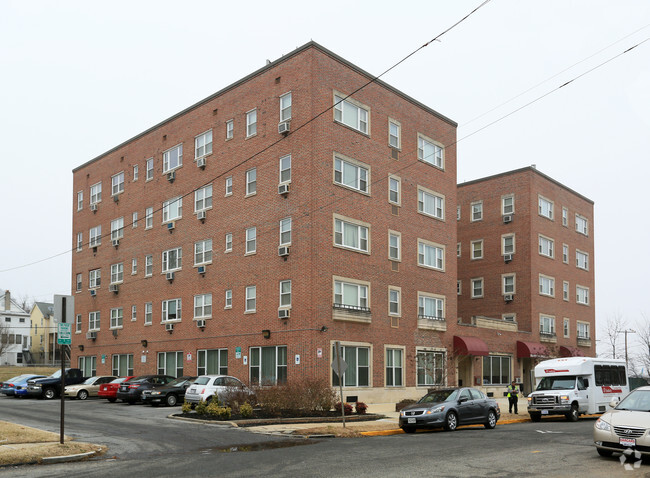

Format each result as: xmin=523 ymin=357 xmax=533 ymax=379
xmin=72 ymin=42 xmax=456 ymax=402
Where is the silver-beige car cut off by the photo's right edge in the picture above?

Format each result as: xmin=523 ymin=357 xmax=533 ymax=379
xmin=594 ymin=386 xmax=650 ymax=457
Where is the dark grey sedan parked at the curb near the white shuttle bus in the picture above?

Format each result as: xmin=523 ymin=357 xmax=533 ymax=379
xmin=399 ymin=388 xmax=501 ymax=433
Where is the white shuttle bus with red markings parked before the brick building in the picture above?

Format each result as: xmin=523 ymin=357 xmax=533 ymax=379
xmin=528 ymin=357 xmax=630 ymax=422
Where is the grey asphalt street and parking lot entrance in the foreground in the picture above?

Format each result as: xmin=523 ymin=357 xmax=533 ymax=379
xmin=0 ymin=398 xmax=636 ymax=478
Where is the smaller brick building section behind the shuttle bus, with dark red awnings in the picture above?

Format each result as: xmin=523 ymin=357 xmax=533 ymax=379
xmin=456 ymin=166 xmax=595 ymax=395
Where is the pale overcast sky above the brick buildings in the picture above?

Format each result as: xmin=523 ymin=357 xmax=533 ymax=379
xmin=0 ymin=0 xmax=650 ymax=362
